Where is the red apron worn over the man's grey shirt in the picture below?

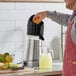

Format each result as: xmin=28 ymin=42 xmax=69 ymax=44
xmin=62 ymin=17 xmax=76 ymax=76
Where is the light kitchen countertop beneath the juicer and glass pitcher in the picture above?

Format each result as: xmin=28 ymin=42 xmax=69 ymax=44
xmin=0 ymin=62 xmax=63 ymax=76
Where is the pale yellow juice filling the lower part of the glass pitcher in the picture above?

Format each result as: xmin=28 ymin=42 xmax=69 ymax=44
xmin=39 ymin=55 xmax=52 ymax=69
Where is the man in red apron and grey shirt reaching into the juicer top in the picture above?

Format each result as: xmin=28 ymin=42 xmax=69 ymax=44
xmin=33 ymin=0 xmax=76 ymax=76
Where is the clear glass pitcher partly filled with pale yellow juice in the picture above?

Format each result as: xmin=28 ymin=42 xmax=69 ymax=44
xmin=39 ymin=46 xmax=52 ymax=69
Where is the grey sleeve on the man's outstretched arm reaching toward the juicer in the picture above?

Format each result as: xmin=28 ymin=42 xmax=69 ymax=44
xmin=47 ymin=11 xmax=71 ymax=26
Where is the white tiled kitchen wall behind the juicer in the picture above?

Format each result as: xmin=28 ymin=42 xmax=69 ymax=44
xmin=0 ymin=2 xmax=70 ymax=61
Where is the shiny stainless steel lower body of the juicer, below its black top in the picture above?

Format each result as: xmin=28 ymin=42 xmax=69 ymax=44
xmin=27 ymin=38 xmax=40 ymax=67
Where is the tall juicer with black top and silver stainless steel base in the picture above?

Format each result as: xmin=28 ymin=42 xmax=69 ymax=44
xmin=27 ymin=15 xmax=44 ymax=67
